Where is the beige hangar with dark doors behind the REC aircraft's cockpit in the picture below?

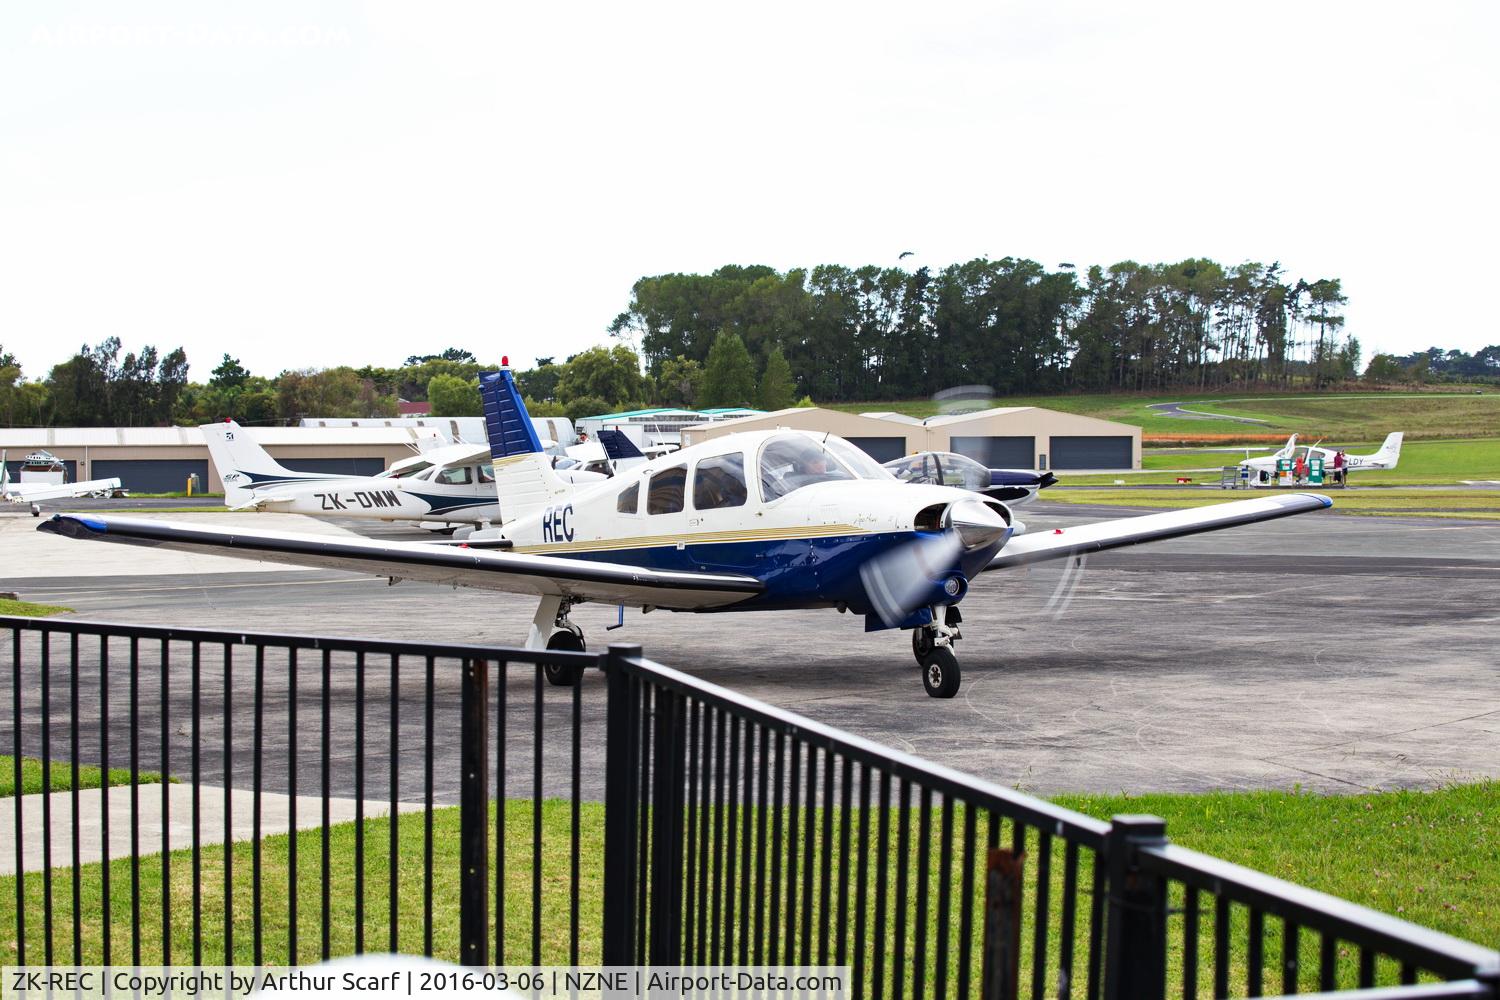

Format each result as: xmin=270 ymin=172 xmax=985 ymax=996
xmin=683 ymin=406 xmax=1140 ymax=469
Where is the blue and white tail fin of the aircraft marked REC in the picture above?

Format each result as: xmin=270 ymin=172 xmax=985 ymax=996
xmin=479 ymin=365 xmax=573 ymax=523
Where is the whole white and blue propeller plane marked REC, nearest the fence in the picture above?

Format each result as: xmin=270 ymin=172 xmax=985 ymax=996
xmin=39 ymin=367 xmax=1332 ymax=697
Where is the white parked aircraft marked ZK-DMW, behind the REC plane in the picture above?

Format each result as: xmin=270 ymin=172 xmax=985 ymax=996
xmin=203 ymin=421 xmax=606 ymax=526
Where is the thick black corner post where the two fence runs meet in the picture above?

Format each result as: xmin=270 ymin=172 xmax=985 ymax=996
xmin=602 ymin=643 xmax=641 ymax=966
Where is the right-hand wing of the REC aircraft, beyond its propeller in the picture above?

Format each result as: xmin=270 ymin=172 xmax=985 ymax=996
xmin=984 ymin=493 xmax=1334 ymax=571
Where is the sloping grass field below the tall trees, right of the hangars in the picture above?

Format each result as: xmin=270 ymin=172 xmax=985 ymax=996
xmin=828 ymin=390 xmax=1500 ymax=444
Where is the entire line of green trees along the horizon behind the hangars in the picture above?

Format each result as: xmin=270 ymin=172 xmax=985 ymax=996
xmin=0 ymin=258 xmax=1500 ymax=426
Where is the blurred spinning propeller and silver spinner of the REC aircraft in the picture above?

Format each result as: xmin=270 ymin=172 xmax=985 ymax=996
xmin=860 ymin=499 xmax=1010 ymax=628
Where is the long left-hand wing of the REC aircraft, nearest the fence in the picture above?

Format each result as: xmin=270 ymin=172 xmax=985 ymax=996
xmin=38 ymin=514 xmax=762 ymax=610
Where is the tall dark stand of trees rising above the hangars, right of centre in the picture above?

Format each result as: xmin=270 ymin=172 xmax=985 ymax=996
xmin=609 ymin=258 xmax=1359 ymax=402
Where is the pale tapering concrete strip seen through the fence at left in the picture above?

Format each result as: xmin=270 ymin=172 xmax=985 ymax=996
xmin=0 ymin=784 xmax=423 ymax=876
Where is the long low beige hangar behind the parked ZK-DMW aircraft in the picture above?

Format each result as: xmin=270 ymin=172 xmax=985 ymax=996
xmin=0 ymin=427 xmax=432 ymax=493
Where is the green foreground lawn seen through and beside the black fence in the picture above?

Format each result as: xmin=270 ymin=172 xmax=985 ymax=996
xmin=0 ymin=783 xmax=1500 ymax=991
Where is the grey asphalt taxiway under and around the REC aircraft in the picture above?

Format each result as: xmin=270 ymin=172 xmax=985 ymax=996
xmin=0 ymin=498 xmax=1500 ymax=793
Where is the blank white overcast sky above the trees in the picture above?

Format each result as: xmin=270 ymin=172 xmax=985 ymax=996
xmin=0 ymin=0 xmax=1500 ymax=381
